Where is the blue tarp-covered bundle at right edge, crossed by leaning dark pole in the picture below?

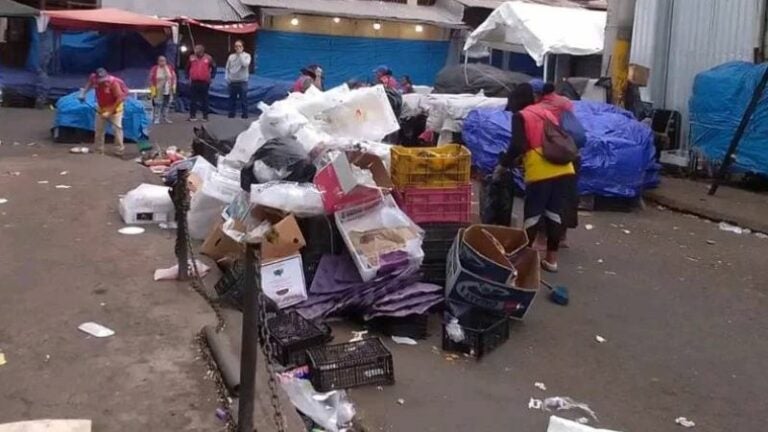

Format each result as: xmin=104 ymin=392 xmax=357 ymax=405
xmin=689 ymin=62 xmax=768 ymax=174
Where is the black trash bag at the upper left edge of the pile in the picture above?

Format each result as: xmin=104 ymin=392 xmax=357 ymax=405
xmin=192 ymin=118 xmax=250 ymax=166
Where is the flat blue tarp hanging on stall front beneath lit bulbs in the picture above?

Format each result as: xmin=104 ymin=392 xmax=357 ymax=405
xmin=256 ymin=30 xmax=449 ymax=87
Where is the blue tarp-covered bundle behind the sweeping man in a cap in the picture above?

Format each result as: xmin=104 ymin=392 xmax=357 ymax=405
xmin=53 ymin=90 xmax=150 ymax=141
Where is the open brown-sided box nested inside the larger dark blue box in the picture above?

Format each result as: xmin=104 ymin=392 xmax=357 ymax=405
xmin=459 ymin=225 xmax=528 ymax=284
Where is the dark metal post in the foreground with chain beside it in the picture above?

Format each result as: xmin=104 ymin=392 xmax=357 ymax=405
xmin=237 ymin=244 xmax=260 ymax=432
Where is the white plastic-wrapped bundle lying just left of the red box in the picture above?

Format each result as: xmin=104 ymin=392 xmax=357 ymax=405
xmin=251 ymin=182 xmax=325 ymax=218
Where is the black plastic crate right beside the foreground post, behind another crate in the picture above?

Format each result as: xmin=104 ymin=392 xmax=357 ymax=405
xmin=267 ymin=311 xmax=330 ymax=366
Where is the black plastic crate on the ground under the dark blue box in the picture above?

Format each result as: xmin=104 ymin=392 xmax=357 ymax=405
xmin=443 ymin=308 xmax=509 ymax=360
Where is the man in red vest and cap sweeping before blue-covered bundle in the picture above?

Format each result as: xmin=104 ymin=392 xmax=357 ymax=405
xmin=78 ymin=68 xmax=128 ymax=156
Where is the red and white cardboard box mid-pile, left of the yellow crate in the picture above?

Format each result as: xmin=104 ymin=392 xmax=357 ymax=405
xmin=314 ymin=152 xmax=394 ymax=214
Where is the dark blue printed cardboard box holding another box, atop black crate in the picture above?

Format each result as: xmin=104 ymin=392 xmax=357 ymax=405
xmin=445 ymin=230 xmax=541 ymax=319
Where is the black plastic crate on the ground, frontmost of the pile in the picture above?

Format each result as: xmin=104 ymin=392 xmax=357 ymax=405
xmin=307 ymin=338 xmax=395 ymax=392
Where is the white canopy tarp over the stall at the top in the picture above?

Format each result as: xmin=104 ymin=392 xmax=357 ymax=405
xmin=464 ymin=1 xmax=607 ymax=66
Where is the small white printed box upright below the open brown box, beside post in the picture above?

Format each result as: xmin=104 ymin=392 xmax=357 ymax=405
xmin=261 ymin=255 xmax=307 ymax=309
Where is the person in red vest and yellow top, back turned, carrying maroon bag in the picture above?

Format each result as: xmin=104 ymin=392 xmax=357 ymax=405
xmin=494 ymin=83 xmax=575 ymax=273
